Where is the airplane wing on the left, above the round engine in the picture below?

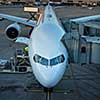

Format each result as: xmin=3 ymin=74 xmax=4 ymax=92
xmin=0 ymin=14 xmax=36 ymax=27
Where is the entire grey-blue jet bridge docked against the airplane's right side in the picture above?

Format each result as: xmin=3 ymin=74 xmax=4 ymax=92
xmin=61 ymin=18 xmax=100 ymax=64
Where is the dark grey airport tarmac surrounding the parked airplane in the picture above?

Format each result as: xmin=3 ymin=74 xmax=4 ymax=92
xmin=0 ymin=6 xmax=100 ymax=100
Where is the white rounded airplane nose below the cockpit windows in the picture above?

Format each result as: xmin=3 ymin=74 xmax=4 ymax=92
xmin=32 ymin=64 xmax=66 ymax=88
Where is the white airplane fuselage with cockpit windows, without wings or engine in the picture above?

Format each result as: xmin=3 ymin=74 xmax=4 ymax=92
xmin=29 ymin=5 xmax=68 ymax=88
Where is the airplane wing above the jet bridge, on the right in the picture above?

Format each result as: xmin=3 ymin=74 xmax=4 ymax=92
xmin=70 ymin=15 xmax=100 ymax=23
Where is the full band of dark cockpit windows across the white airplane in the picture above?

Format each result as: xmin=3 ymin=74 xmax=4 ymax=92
xmin=33 ymin=54 xmax=65 ymax=66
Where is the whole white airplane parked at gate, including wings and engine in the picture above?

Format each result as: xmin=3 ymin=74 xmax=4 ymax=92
xmin=0 ymin=4 xmax=100 ymax=88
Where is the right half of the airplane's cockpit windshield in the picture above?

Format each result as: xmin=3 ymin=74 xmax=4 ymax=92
xmin=50 ymin=55 xmax=65 ymax=66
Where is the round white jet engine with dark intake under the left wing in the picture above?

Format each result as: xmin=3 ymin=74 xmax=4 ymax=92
xmin=5 ymin=23 xmax=21 ymax=40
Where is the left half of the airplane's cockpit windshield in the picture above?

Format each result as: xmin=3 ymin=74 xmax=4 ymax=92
xmin=33 ymin=54 xmax=48 ymax=66
